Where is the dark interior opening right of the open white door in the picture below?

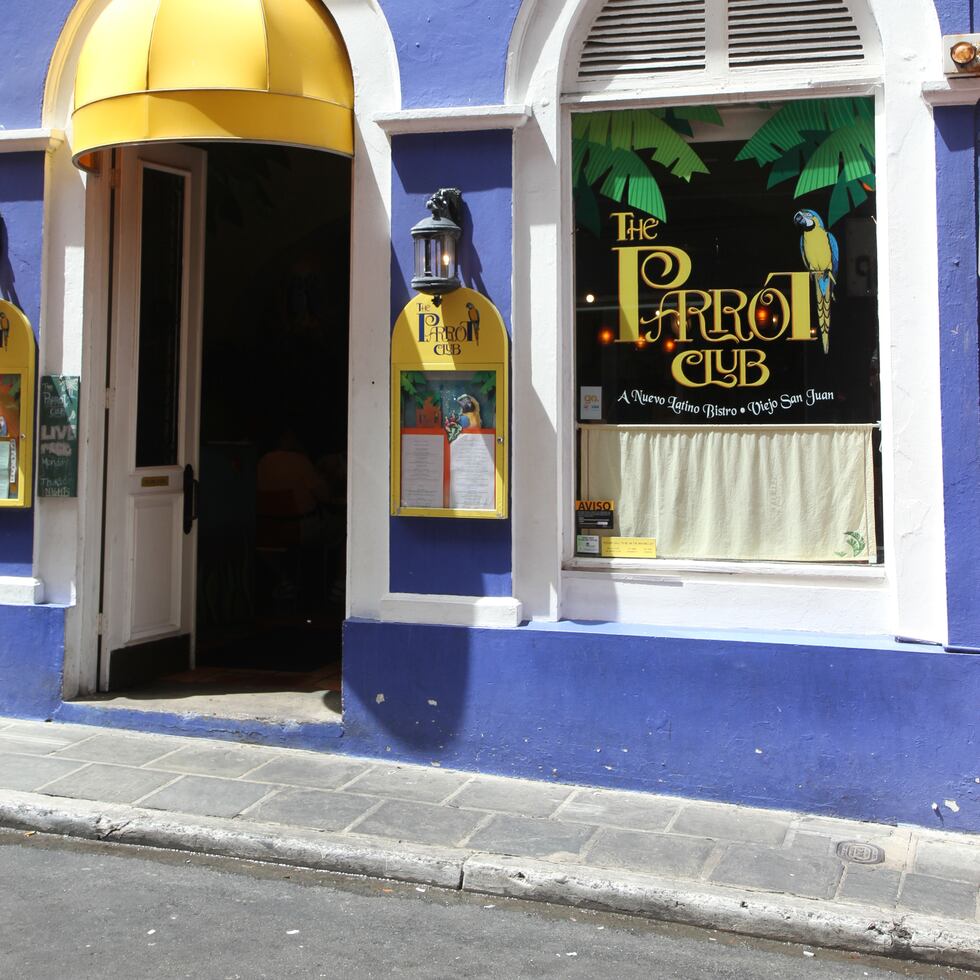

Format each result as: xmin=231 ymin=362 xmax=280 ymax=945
xmin=189 ymin=144 xmax=351 ymax=701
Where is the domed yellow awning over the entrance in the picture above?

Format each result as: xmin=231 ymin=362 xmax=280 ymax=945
xmin=72 ymin=0 xmax=354 ymax=161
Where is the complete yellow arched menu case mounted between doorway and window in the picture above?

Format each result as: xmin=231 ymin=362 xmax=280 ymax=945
xmin=391 ymin=289 xmax=508 ymax=518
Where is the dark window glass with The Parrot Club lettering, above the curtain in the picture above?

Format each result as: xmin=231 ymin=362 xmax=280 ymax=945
xmin=571 ymin=98 xmax=880 ymax=561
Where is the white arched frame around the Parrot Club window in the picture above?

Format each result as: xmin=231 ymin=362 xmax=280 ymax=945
xmin=507 ymin=0 xmax=946 ymax=642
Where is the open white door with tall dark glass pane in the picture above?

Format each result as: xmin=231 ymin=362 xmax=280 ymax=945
xmin=99 ymin=144 xmax=207 ymax=690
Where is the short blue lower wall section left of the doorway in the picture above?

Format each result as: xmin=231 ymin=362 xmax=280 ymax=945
xmin=0 ymin=606 xmax=65 ymax=718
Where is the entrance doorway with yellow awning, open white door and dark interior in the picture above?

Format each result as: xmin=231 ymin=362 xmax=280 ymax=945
xmin=38 ymin=0 xmax=397 ymax=720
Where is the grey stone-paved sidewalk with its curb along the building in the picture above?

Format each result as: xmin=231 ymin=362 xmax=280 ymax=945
xmin=0 ymin=719 xmax=980 ymax=968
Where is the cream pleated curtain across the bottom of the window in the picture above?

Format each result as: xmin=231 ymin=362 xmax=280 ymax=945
xmin=581 ymin=425 xmax=877 ymax=562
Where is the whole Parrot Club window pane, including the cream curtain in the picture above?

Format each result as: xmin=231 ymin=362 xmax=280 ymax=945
xmin=572 ymin=98 xmax=881 ymax=562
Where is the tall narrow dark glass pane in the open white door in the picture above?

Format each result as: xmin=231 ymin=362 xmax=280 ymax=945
xmin=136 ymin=167 xmax=186 ymax=466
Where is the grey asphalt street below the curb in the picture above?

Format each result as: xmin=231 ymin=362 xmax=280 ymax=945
xmin=0 ymin=831 xmax=971 ymax=980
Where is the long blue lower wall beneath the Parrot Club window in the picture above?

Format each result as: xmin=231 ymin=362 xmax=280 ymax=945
xmin=342 ymin=621 xmax=980 ymax=831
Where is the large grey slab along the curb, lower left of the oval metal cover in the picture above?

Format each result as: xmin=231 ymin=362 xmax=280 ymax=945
xmin=710 ymin=844 xmax=844 ymax=898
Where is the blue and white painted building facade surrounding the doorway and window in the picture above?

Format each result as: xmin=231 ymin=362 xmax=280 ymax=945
xmin=0 ymin=0 xmax=980 ymax=832
